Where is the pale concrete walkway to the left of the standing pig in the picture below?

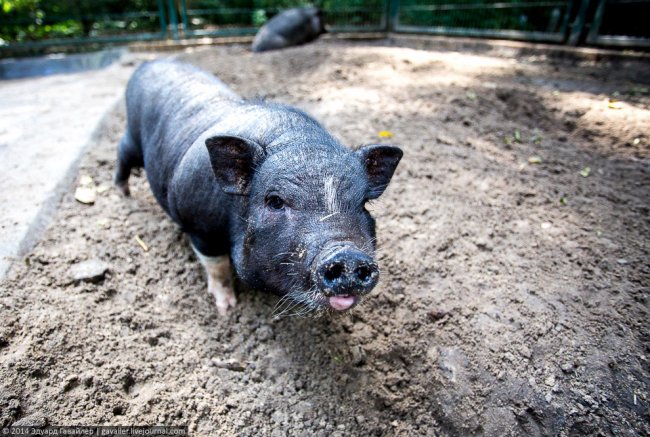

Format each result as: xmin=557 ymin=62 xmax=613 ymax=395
xmin=0 ymin=54 xmax=150 ymax=279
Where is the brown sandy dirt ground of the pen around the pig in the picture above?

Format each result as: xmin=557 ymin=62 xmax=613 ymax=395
xmin=0 ymin=42 xmax=650 ymax=436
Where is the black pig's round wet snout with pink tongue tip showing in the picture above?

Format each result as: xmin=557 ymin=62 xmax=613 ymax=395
xmin=312 ymin=245 xmax=379 ymax=311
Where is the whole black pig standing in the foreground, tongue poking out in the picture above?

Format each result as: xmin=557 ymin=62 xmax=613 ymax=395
xmin=115 ymin=61 xmax=402 ymax=313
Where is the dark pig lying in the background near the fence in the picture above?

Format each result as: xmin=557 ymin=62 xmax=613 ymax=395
xmin=252 ymin=7 xmax=326 ymax=52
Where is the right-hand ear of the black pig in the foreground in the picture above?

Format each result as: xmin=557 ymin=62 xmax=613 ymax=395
xmin=355 ymin=144 xmax=403 ymax=199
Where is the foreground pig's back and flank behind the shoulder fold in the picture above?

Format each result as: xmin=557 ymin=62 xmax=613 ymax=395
xmin=126 ymin=60 xmax=239 ymax=218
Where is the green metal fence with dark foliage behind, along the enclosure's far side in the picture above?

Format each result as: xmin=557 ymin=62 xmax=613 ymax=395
xmin=0 ymin=0 xmax=650 ymax=56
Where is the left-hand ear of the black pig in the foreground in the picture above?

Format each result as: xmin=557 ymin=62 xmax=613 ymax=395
xmin=205 ymin=136 xmax=264 ymax=196
